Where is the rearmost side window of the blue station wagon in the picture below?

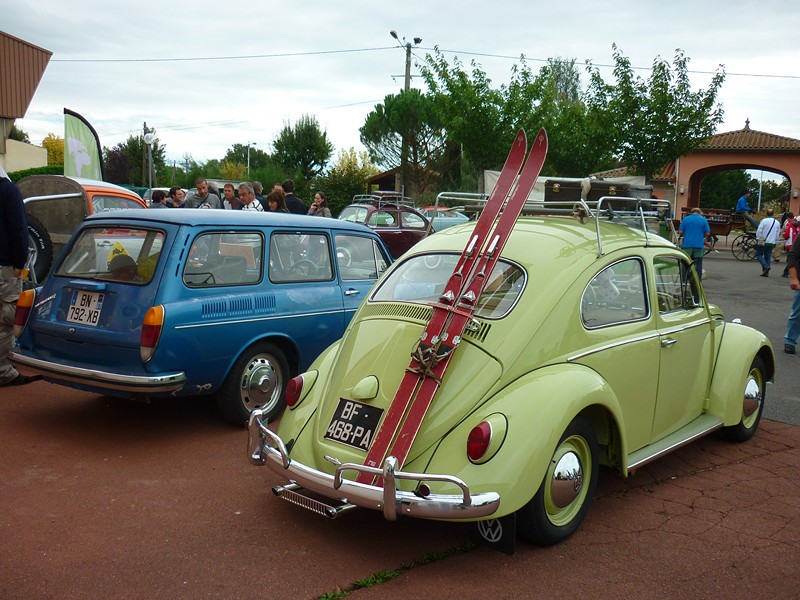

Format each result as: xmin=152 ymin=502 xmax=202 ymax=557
xmin=183 ymin=231 xmax=264 ymax=287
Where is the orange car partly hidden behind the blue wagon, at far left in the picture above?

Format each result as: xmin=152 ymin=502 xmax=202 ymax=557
xmin=17 ymin=175 xmax=147 ymax=282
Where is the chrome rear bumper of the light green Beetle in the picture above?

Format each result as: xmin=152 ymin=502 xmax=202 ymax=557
xmin=248 ymin=410 xmax=500 ymax=521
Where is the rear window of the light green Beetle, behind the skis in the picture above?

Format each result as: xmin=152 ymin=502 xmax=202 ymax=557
xmin=372 ymin=254 xmax=525 ymax=319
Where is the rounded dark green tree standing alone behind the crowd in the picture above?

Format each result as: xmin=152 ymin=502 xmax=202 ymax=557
xmin=268 ymin=115 xmax=333 ymax=184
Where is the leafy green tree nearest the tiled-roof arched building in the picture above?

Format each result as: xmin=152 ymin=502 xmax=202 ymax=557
xmin=588 ymin=44 xmax=725 ymax=177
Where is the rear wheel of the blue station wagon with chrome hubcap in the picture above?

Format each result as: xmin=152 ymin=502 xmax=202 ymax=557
xmin=217 ymin=342 xmax=289 ymax=425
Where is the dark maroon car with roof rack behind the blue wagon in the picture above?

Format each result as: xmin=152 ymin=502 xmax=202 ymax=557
xmin=339 ymin=196 xmax=432 ymax=258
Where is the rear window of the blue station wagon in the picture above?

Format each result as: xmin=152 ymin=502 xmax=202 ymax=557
xmin=56 ymin=227 xmax=164 ymax=285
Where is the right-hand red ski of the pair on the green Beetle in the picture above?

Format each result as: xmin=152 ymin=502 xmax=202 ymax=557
xmin=387 ymin=129 xmax=547 ymax=467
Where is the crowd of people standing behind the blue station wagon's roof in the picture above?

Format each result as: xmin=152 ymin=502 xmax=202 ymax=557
xmin=150 ymin=177 xmax=333 ymax=217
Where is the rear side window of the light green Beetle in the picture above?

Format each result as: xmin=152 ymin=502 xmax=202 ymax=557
xmin=581 ymin=258 xmax=650 ymax=329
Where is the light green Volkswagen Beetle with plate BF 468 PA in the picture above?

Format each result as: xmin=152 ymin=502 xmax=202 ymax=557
xmin=248 ymin=200 xmax=775 ymax=545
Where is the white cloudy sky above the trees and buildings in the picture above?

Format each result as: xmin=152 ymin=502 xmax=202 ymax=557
xmin=6 ymin=0 xmax=800 ymax=170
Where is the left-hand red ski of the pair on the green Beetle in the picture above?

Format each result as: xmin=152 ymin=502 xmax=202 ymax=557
xmin=356 ymin=129 xmax=528 ymax=483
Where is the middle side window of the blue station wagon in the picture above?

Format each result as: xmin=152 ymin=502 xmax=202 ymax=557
xmin=269 ymin=232 xmax=333 ymax=283
